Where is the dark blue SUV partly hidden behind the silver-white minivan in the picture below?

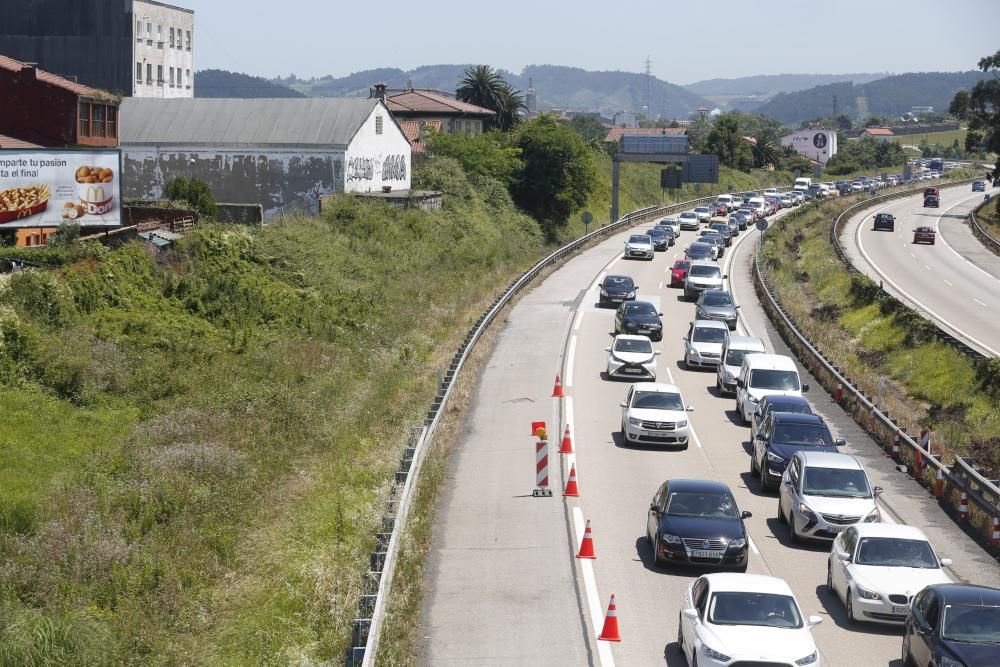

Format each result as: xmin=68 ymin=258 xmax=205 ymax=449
xmin=750 ymin=412 xmax=845 ymax=491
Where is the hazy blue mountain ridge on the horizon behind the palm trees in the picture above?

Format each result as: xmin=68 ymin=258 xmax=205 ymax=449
xmin=276 ymin=65 xmax=712 ymax=119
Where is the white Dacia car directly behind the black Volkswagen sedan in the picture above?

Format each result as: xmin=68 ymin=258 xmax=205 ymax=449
xmin=621 ymin=382 xmax=694 ymax=449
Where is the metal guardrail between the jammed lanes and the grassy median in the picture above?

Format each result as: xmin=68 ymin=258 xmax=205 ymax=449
xmin=753 ymin=202 xmax=1000 ymax=542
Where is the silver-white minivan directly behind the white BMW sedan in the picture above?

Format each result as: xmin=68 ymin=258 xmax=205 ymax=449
xmin=778 ymin=449 xmax=882 ymax=542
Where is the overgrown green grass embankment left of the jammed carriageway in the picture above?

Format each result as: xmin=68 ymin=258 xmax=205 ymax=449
xmin=0 ymin=159 xmax=545 ymax=666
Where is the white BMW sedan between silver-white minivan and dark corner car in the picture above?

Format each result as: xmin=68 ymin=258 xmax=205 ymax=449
xmin=826 ymin=523 xmax=951 ymax=625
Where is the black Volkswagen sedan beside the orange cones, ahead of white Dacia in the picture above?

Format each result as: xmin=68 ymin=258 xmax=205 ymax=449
xmin=646 ymin=479 xmax=751 ymax=572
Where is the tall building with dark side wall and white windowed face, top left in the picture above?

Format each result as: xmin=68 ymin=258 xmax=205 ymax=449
xmin=0 ymin=0 xmax=194 ymax=98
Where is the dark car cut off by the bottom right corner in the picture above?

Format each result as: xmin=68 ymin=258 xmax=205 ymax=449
xmin=903 ymin=584 xmax=1000 ymax=667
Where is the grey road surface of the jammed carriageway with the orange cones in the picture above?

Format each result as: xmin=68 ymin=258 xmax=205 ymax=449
xmin=421 ymin=201 xmax=1000 ymax=666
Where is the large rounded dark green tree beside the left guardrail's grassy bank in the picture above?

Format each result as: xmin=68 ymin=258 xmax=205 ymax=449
xmin=512 ymin=114 xmax=597 ymax=240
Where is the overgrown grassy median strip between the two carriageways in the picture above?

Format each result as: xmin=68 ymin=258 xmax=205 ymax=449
xmin=762 ymin=175 xmax=1000 ymax=471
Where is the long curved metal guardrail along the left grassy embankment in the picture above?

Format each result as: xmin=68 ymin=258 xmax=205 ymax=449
xmin=346 ymin=188 xmax=752 ymax=667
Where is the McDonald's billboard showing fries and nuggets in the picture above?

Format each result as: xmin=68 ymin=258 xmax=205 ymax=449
xmin=0 ymin=150 xmax=122 ymax=229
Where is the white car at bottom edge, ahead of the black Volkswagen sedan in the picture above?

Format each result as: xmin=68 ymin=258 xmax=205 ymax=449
xmin=677 ymin=572 xmax=823 ymax=667
